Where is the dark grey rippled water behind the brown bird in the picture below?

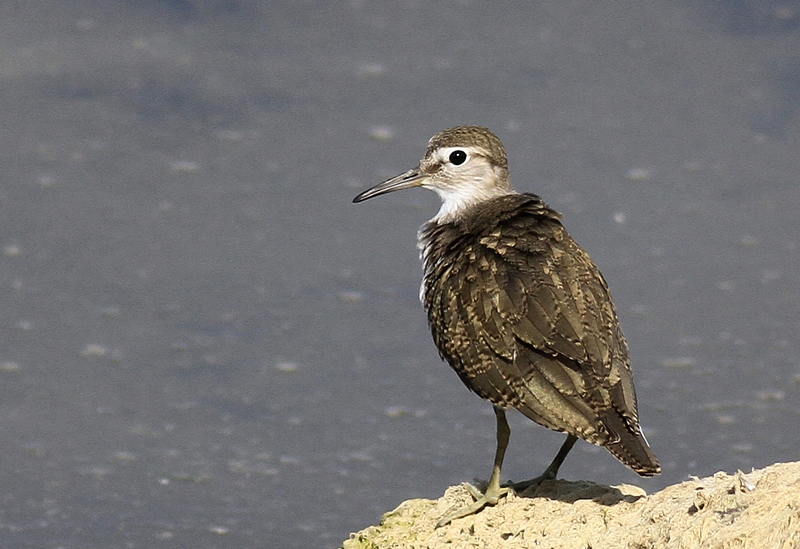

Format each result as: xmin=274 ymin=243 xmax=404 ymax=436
xmin=0 ymin=0 xmax=800 ymax=548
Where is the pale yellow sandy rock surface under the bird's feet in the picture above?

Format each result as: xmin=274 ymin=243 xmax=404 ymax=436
xmin=343 ymin=462 xmax=800 ymax=549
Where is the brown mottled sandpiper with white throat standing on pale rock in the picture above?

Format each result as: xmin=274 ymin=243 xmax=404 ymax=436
xmin=353 ymin=126 xmax=661 ymax=527
